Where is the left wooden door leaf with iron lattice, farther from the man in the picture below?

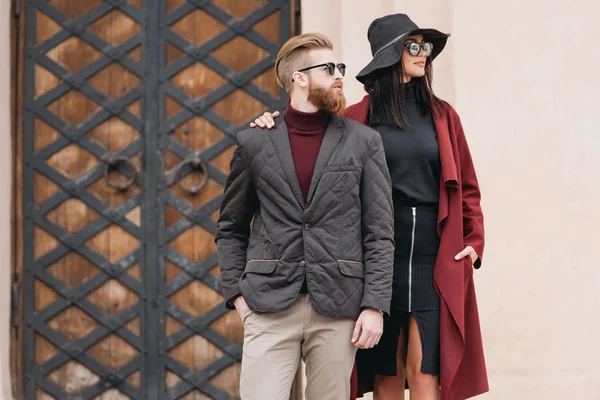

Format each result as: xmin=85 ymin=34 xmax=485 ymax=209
xmin=21 ymin=0 xmax=145 ymax=399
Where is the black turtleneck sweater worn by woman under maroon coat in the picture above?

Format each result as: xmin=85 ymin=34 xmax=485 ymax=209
xmin=372 ymin=83 xmax=442 ymax=207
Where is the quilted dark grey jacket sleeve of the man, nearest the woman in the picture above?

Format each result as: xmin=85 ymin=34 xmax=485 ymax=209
xmin=360 ymin=133 xmax=394 ymax=314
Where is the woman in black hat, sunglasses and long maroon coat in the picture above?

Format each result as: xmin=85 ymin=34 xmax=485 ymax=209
xmin=248 ymin=14 xmax=488 ymax=400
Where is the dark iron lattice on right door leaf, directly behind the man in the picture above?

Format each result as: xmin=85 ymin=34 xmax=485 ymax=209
xmin=157 ymin=0 xmax=291 ymax=399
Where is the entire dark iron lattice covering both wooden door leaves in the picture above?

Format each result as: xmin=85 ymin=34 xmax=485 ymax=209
xmin=23 ymin=0 xmax=290 ymax=399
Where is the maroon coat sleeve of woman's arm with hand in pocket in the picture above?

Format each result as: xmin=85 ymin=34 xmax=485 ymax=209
xmin=454 ymin=114 xmax=485 ymax=268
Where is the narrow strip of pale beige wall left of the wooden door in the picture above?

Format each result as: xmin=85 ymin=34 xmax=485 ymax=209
xmin=0 ymin=0 xmax=12 ymax=400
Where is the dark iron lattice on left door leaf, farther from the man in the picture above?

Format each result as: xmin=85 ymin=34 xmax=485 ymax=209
xmin=23 ymin=1 xmax=147 ymax=399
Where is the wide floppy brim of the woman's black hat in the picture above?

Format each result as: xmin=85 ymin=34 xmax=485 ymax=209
xmin=356 ymin=29 xmax=450 ymax=84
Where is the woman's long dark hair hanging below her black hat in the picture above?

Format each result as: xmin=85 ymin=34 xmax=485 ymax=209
xmin=365 ymin=55 xmax=448 ymax=127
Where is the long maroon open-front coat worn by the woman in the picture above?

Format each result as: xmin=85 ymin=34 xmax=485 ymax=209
xmin=345 ymin=96 xmax=489 ymax=400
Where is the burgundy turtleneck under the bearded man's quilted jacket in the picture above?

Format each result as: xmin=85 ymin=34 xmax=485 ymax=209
xmin=285 ymin=103 xmax=329 ymax=202
